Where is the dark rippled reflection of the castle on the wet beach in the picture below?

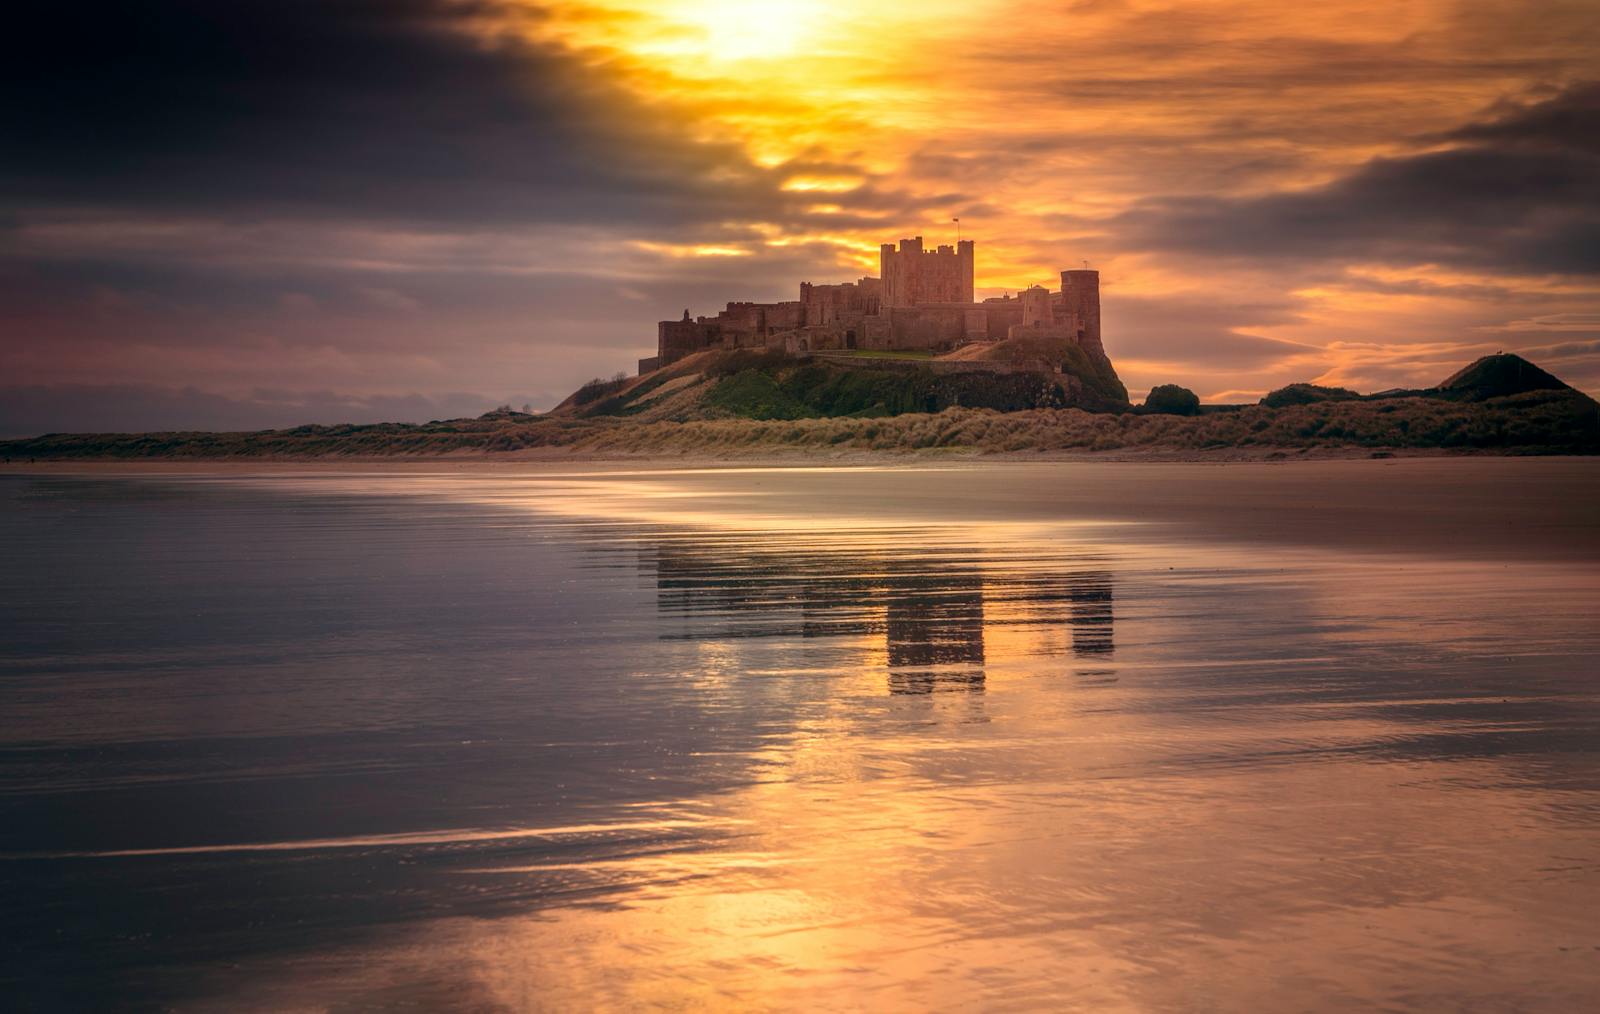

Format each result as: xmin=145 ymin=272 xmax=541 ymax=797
xmin=638 ymin=533 xmax=1115 ymax=694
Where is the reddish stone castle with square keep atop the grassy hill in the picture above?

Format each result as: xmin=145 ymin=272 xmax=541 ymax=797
xmin=638 ymin=237 xmax=1106 ymax=373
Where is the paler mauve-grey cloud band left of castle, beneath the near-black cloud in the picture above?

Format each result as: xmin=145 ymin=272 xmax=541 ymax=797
xmin=0 ymin=232 xmax=848 ymax=435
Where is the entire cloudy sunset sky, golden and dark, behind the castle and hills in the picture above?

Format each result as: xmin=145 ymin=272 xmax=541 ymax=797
xmin=0 ymin=0 xmax=1600 ymax=435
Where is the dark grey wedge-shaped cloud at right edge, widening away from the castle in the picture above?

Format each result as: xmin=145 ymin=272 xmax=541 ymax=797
xmin=1110 ymin=85 xmax=1600 ymax=275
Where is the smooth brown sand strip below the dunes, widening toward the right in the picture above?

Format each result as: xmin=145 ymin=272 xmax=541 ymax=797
xmin=0 ymin=456 xmax=1600 ymax=560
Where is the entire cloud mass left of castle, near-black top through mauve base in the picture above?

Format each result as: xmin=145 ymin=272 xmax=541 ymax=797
xmin=0 ymin=0 xmax=946 ymax=432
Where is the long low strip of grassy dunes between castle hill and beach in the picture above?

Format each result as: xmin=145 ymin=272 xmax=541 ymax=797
xmin=0 ymin=387 xmax=1600 ymax=467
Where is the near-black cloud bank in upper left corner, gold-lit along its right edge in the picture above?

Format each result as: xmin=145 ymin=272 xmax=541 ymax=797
xmin=0 ymin=0 xmax=800 ymax=224
